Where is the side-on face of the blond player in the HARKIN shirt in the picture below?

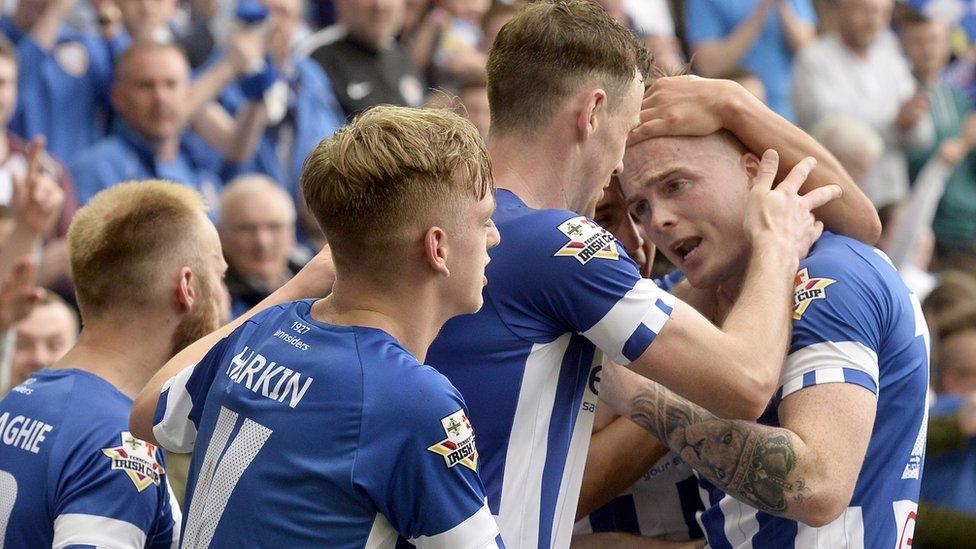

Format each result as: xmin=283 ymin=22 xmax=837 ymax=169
xmin=449 ymin=193 xmax=500 ymax=314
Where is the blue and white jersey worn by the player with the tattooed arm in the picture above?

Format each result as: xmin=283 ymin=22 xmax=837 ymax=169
xmin=700 ymin=232 xmax=929 ymax=549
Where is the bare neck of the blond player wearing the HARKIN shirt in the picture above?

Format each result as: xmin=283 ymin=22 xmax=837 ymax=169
xmin=311 ymin=278 xmax=446 ymax=362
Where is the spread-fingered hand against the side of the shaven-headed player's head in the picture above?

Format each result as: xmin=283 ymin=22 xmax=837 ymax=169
xmin=745 ymin=149 xmax=841 ymax=259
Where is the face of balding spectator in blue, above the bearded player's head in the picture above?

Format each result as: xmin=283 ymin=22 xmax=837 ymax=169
xmin=115 ymin=48 xmax=189 ymax=139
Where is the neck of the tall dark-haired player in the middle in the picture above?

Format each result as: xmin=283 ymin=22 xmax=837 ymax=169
xmin=488 ymin=135 xmax=577 ymax=210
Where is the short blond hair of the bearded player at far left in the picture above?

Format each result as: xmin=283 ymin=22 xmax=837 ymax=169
xmin=68 ymin=180 xmax=207 ymax=317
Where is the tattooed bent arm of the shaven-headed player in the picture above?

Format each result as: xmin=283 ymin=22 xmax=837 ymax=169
xmin=600 ymin=367 xmax=876 ymax=527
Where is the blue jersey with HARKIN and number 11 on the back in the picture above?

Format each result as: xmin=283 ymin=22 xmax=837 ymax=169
xmin=153 ymin=300 xmax=498 ymax=548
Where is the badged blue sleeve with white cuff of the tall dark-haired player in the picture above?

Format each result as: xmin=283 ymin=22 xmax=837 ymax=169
xmin=500 ymin=215 xmax=675 ymax=365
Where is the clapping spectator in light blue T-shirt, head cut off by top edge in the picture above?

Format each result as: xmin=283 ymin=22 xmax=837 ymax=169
xmin=684 ymin=0 xmax=816 ymax=121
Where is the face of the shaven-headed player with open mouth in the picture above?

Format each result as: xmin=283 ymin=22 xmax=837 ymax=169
xmin=620 ymin=136 xmax=750 ymax=288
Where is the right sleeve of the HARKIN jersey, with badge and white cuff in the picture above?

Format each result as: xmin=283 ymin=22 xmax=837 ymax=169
xmin=353 ymin=370 xmax=503 ymax=549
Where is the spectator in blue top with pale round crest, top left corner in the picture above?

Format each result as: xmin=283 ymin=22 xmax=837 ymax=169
xmin=0 ymin=0 xmax=122 ymax=163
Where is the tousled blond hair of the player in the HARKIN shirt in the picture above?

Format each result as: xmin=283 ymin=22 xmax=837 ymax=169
xmin=301 ymin=106 xmax=493 ymax=265
